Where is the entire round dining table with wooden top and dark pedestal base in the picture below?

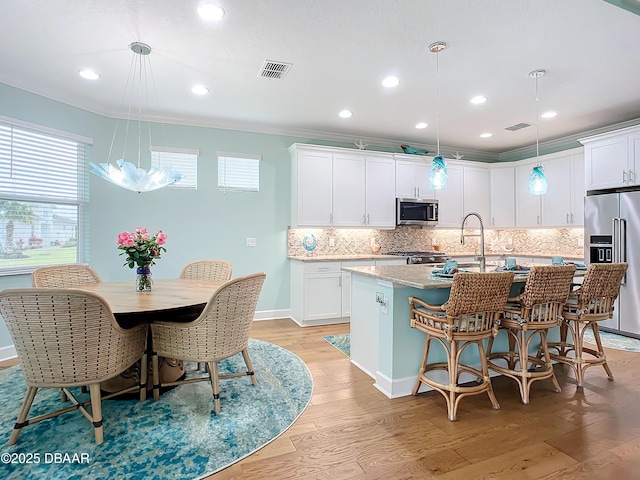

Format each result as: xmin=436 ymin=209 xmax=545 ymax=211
xmin=73 ymin=278 xmax=224 ymax=393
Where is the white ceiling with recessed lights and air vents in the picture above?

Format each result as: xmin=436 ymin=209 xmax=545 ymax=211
xmin=0 ymin=0 xmax=640 ymax=158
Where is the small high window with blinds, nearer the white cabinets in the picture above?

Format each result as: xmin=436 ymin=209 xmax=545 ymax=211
xmin=218 ymin=152 xmax=260 ymax=192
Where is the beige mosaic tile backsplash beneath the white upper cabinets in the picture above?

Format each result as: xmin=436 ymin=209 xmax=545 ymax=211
xmin=287 ymin=226 xmax=584 ymax=258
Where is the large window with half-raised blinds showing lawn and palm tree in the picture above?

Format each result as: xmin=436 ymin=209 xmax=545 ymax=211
xmin=0 ymin=117 xmax=92 ymax=275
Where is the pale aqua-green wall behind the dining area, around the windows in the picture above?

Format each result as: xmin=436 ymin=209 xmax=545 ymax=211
xmin=0 ymin=83 xmax=356 ymax=348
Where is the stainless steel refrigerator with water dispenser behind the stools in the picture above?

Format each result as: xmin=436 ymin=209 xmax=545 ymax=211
xmin=584 ymin=189 xmax=640 ymax=338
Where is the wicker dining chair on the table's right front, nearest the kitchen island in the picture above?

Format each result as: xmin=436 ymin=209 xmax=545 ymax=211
xmin=151 ymin=273 xmax=266 ymax=413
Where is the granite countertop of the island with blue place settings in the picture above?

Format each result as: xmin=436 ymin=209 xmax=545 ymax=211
xmin=342 ymin=264 xmax=584 ymax=290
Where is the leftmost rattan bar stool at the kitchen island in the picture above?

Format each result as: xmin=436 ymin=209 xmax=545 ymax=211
xmin=409 ymin=272 xmax=514 ymax=421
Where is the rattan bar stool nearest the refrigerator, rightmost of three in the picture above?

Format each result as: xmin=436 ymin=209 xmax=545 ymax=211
xmin=549 ymin=262 xmax=627 ymax=387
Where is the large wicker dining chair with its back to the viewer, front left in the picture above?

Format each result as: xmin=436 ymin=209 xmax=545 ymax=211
xmin=0 ymin=288 xmax=148 ymax=445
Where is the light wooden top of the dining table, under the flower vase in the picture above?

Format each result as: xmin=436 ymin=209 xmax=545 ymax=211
xmin=74 ymin=278 xmax=224 ymax=314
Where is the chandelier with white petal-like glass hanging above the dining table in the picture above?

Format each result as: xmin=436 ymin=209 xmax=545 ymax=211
xmin=89 ymin=42 xmax=183 ymax=193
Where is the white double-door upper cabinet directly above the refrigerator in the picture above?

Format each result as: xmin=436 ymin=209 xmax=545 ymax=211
xmin=580 ymin=126 xmax=640 ymax=190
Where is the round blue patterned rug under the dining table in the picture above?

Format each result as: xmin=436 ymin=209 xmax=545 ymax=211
xmin=0 ymin=339 xmax=313 ymax=480
